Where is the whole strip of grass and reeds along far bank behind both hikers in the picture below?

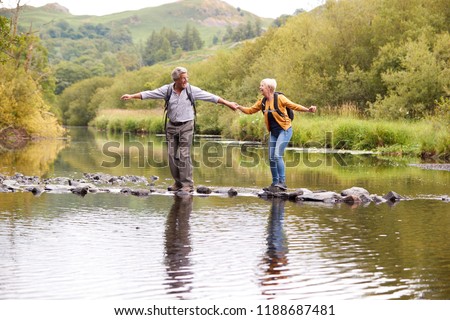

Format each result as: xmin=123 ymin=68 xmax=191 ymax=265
xmin=90 ymin=107 xmax=450 ymax=162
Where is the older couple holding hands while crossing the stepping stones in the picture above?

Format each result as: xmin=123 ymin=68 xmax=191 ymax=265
xmin=120 ymin=67 xmax=316 ymax=192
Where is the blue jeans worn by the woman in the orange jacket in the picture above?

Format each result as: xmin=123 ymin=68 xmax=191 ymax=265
xmin=269 ymin=127 xmax=292 ymax=184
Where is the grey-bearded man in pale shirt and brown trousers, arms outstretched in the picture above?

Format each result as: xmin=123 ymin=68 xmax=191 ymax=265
xmin=120 ymin=67 xmax=238 ymax=192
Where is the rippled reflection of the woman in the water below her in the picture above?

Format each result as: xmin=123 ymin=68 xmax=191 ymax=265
xmin=261 ymin=198 xmax=288 ymax=295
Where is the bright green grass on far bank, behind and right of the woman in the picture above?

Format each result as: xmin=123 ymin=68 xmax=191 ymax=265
xmin=218 ymin=114 xmax=450 ymax=160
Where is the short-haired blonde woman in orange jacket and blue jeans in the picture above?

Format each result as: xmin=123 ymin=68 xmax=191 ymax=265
xmin=238 ymin=79 xmax=317 ymax=190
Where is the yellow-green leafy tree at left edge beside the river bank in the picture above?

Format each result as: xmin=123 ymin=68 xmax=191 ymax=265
xmin=0 ymin=10 xmax=63 ymax=136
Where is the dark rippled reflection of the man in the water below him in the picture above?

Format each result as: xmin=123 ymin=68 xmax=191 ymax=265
xmin=165 ymin=195 xmax=192 ymax=299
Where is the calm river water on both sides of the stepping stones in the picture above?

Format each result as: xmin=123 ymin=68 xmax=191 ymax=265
xmin=0 ymin=128 xmax=450 ymax=299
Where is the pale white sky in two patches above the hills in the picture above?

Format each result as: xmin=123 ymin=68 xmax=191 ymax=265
xmin=0 ymin=0 xmax=325 ymax=18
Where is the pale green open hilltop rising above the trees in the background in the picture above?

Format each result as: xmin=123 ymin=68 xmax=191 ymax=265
xmin=0 ymin=0 xmax=273 ymax=46
